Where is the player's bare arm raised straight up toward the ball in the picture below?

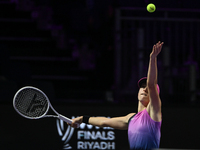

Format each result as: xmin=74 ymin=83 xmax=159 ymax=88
xmin=147 ymin=42 xmax=164 ymax=121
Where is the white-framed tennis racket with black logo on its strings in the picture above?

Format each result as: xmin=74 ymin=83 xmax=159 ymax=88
xmin=13 ymin=86 xmax=79 ymax=127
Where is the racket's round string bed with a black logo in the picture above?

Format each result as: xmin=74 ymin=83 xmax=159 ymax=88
xmin=15 ymin=89 xmax=48 ymax=118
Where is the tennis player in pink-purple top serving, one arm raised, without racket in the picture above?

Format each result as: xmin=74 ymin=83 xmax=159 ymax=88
xmin=71 ymin=42 xmax=164 ymax=150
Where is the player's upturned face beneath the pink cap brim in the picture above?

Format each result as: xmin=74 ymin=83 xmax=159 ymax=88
xmin=138 ymin=84 xmax=149 ymax=102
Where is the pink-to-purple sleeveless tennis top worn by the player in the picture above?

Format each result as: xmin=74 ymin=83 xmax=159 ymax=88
xmin=128 ymin=109 xmax=162 ymax=150
